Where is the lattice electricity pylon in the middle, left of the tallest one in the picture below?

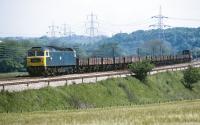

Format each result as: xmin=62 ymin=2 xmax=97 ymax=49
xmin=86 ymin=13 xmax=99 ymax=38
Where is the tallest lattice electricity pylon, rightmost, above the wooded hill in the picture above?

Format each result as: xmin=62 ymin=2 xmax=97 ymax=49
xmin=150 ymin=6 xmax=170 ymax=40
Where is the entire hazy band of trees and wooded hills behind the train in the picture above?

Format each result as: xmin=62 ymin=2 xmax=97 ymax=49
xmin=0 ymin=28 xmax=200 ymax=72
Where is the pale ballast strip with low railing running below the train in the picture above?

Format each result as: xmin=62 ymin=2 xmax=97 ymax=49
xmin=0 ymin=61 xmax=200 ymax=92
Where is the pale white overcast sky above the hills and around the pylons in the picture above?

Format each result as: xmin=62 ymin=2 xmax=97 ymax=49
xmin=0 ymin=0 xmax=200 ymax=36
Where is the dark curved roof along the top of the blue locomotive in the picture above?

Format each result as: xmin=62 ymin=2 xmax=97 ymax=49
xmin=32 ymin=46 xmax=74 ymax=51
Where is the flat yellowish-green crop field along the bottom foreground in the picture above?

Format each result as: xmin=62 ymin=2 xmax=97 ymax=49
xmin=0 ymin=100 xmax=200 ymax=125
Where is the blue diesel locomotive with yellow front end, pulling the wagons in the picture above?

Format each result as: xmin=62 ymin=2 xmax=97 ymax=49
xmin=27 ymin=46 xmax=76 ymax=75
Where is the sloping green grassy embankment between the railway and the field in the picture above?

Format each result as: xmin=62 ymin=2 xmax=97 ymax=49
xmin=0 ymin=71 xmax=200 ymax=112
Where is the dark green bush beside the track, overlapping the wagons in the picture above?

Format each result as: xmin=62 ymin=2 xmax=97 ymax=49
xmin=128 ymin=60 xmax=155 ymax=81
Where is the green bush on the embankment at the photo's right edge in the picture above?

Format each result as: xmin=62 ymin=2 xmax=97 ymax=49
xmin=183 ymin=66 xmax=200 ymax=89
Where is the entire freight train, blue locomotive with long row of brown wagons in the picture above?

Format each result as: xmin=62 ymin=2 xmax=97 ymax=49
xmin=26 ymin=46 xmax=192 ymax=76
